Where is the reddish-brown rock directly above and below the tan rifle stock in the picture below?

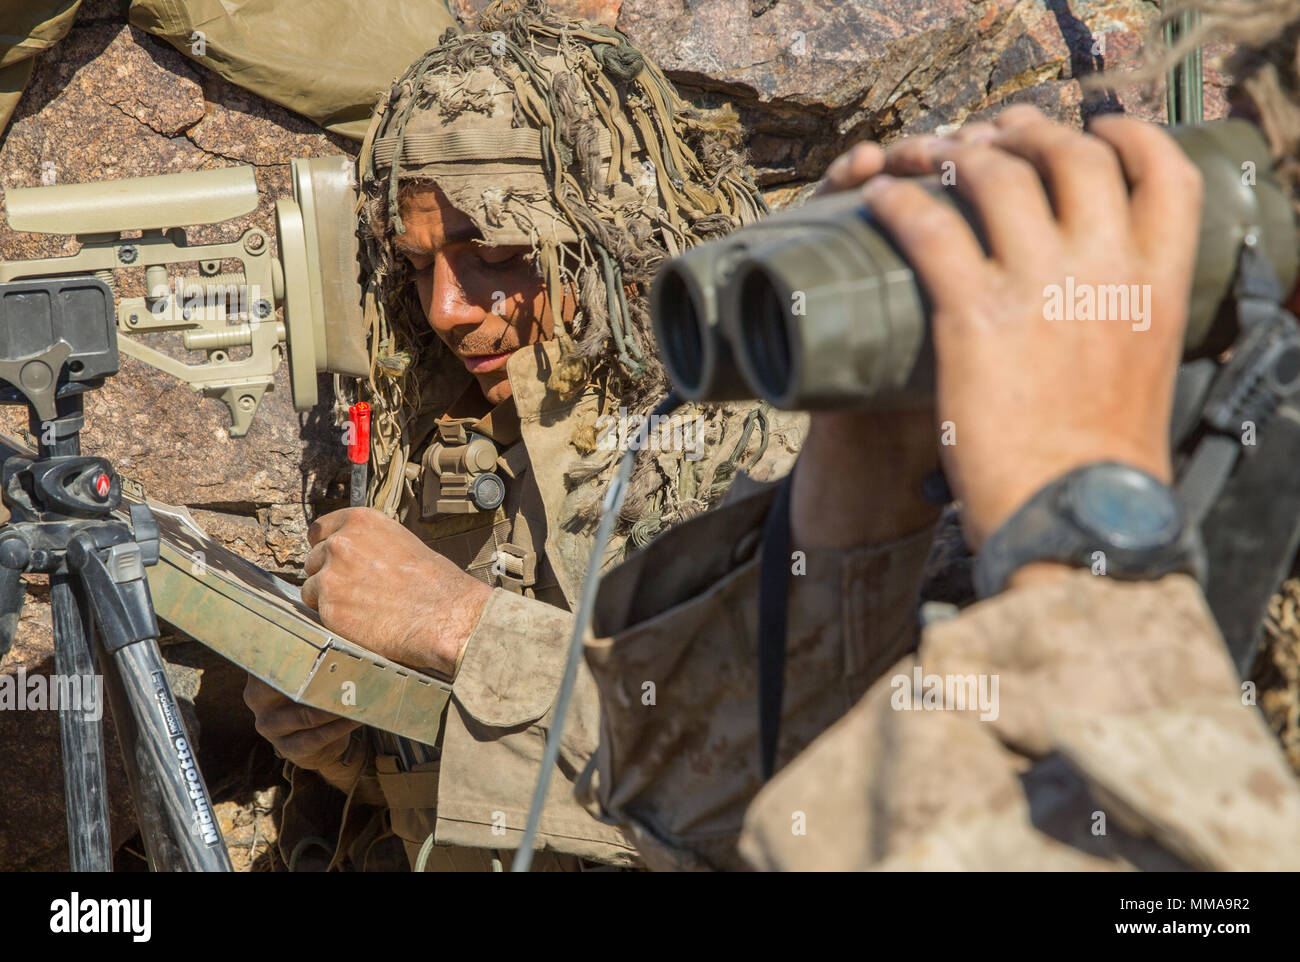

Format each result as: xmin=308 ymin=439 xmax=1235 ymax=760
xmin=0 ymin=16 xmax=352 ymax=571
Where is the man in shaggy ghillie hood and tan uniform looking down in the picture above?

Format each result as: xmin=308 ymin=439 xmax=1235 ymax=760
xmin=265 ymin=3 xmax=805 ymax=870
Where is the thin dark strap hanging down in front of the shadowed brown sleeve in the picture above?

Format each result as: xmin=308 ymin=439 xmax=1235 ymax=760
xmin=758 ymin=475 xmax=793 ymax=781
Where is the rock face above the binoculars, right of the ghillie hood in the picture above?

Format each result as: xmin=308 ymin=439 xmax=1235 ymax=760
xmin=456 ymin=0 xmax=1223 ymax=203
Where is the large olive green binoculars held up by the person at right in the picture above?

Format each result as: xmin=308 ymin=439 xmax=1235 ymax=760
xmin=650 ymin=120 xmax=1300 ymax=411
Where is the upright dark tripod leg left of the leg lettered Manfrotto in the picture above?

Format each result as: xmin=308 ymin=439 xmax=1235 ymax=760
xmin=49 ymin=575 xmax=113 ymax=872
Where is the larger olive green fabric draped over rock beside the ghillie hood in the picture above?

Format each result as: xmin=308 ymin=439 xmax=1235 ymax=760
xmin=128 ymin=0 xmax=459 ymax=140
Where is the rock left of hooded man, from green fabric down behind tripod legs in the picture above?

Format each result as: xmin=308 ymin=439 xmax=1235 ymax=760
xmin=0 ymin=3 xmax=355 ymax=870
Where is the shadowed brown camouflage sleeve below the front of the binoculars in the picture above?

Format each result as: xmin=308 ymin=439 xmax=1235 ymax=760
xmin=579 ymin=484 xmax=932 ymax=870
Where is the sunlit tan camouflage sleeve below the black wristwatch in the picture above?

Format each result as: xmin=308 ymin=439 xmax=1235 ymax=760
xmin=741 ymin=572 xmax=1300 ymax=870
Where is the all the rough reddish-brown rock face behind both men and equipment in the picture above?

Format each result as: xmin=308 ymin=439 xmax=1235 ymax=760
xmin=0 ymin=0 xmax=1223 ymax=870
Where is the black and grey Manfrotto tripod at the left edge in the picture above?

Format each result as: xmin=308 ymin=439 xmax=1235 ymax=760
xmin=0 ymin=285 xmax=231 ymax=872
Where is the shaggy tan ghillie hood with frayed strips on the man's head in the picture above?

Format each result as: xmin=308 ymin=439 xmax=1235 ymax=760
xmin=358 ymin=0 xmax=767 ymax=514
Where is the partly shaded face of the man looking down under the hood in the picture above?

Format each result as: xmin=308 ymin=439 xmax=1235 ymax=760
xmin=395 ymin=186 xmax=576 ymax=404
